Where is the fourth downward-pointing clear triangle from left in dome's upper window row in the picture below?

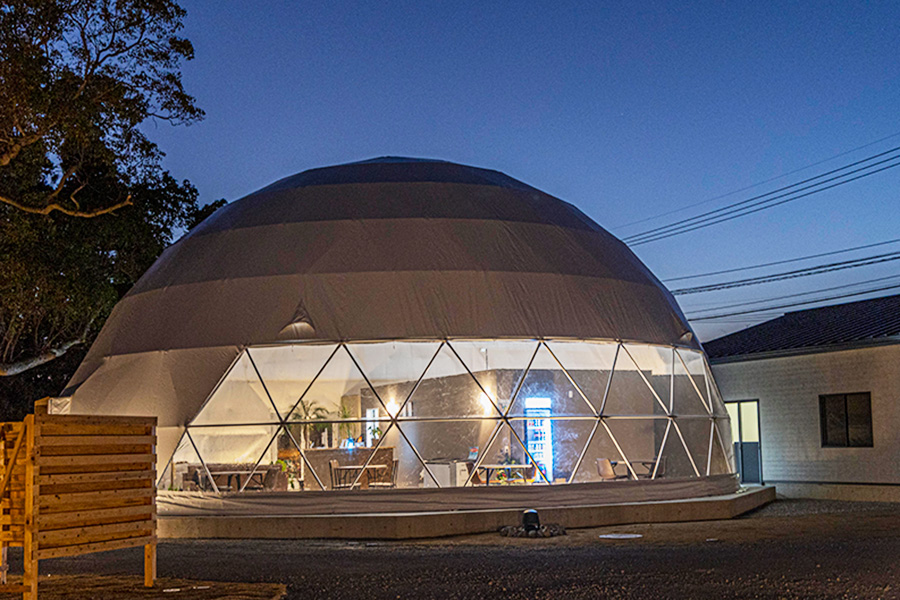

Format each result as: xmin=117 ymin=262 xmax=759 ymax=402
xmin=547 ymin=342 xmax=618 ymax=413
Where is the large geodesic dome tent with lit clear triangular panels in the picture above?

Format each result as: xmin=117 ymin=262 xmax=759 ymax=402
xmin=66 ymin=158 xmax=733 ymax=492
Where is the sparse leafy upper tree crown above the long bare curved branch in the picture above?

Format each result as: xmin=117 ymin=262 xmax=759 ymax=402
xmin=0 ymin=0 xmax=203 ymax=217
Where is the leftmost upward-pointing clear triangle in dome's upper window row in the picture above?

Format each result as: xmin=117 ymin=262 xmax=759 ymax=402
xmin=191 ymin=351 xmax=279 ymax=425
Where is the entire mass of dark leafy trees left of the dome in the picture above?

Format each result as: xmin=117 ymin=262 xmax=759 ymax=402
xmin=0 ymin=0 xmax=214 ymax=408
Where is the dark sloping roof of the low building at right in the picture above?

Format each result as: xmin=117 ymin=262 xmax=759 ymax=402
xmin=703 ymin=294 xmax=900 ymax=363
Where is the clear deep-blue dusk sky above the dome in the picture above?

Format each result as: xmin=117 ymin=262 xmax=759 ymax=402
xmin=148 ymin=0 xmax=900 ymax=339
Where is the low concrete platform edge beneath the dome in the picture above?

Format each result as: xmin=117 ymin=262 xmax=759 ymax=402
xmin=158 ymin=486 xmax=775 ymax=540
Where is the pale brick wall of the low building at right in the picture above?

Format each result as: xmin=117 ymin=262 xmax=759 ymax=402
xmin=713 ymin=345 xmax=900 ymax=499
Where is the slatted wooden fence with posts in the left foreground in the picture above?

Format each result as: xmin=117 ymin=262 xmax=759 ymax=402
xmin=0 ymin=399 xmax=156 ymax=600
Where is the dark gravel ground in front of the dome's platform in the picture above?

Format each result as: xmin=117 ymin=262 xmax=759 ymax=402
xmin=11 ymin=501 xmax=900 ymax=599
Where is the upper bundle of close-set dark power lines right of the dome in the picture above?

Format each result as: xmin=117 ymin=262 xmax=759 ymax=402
xmin=623 ymin=151 xmax=900 ymax=246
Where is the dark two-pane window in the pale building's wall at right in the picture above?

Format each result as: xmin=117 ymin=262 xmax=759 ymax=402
xmin=819 ymin=392 xmax=872 ymax=448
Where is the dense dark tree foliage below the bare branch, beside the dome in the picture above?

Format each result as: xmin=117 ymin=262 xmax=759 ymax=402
xmin=0 ymin=166 xmax=203 ymax=378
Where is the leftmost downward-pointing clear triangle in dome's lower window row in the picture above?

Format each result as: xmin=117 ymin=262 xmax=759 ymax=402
xmin=188 ymin=424 xmax=278 ymax=492
